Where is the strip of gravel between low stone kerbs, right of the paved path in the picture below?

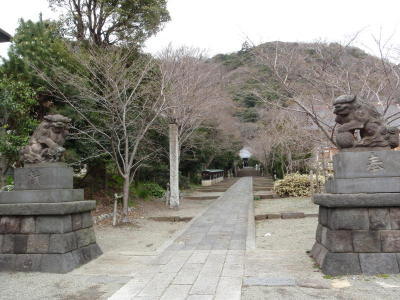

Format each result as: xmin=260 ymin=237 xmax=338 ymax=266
xmin=254 ymin=197 xmax=318 ymax=215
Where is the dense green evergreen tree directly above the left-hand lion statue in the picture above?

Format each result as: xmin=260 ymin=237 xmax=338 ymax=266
xmin=1 ymin=18 xmax=76 ymax=118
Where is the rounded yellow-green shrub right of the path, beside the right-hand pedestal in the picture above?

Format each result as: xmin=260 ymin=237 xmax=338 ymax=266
xmin=274 ymin=173 xmax=324 ymax=197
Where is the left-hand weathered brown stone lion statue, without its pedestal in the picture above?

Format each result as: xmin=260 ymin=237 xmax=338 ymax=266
xmin=21 ymin=115 xmax=71 ymax=163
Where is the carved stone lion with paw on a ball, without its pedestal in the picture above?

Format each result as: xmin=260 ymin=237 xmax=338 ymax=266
xmin=333 ymin=95 xmax=399 ymax=149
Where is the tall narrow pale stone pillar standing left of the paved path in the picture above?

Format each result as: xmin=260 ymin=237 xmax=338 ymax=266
xmin=169 ymin=124 xmax=179 ymax=208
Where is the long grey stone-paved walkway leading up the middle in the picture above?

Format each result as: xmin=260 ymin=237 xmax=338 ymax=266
xmin=110 ymin=177 xmax=253 ymax=300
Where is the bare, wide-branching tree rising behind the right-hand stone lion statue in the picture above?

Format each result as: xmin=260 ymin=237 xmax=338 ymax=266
xmin=252 ymin=39 xmax=400 ymax=144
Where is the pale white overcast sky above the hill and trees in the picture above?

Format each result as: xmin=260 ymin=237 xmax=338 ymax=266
xmin=0 ymin=0 xmax=400 ymax=56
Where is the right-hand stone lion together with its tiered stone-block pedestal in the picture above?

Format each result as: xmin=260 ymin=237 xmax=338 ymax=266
xmin=311 ymin=96 xmax=400 ymax=276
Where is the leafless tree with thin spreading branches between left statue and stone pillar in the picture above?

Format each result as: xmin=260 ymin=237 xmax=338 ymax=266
xmin=42 ymin=48 xmax=167 ymax=214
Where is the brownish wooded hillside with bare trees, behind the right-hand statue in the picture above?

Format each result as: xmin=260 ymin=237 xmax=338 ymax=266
xmin=212 ymin=42 xmax=400 ymax=173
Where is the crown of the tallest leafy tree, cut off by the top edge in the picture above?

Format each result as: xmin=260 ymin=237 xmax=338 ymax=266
xmin=49 ymin=0 xmax=170 ymax=46
